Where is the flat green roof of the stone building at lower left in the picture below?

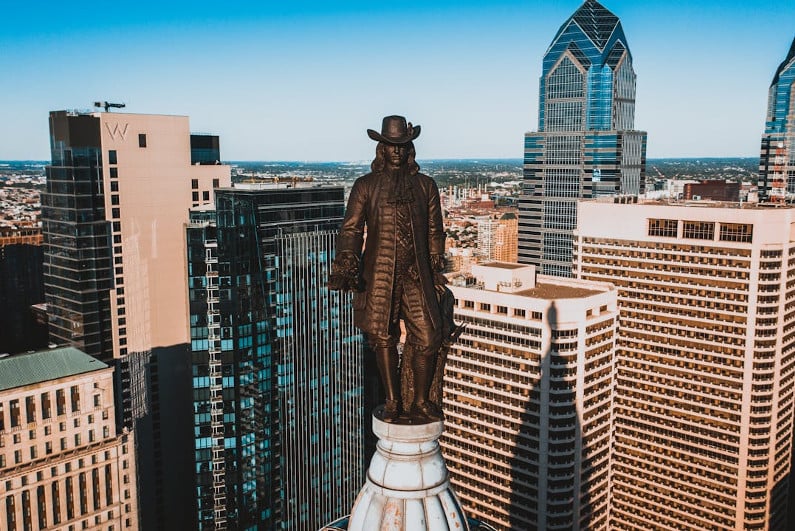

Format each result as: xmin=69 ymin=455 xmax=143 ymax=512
xmin=0 ymin=347 xmax=108 ymax=391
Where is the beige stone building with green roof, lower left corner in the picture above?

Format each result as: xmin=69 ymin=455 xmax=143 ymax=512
xmin=0 ymin=347 xmax=138 ymax=531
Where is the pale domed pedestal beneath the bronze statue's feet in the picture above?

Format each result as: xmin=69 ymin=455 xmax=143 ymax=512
xmin=348 ymin=409 xmax=469 ymax=531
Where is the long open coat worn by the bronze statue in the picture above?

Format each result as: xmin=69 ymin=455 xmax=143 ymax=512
xmin=337 ymin=173 xmax=445 ymax=337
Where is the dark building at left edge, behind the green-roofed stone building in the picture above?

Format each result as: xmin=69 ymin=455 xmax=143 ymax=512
xmin=0 ymin=227 xmax=47 ymax=353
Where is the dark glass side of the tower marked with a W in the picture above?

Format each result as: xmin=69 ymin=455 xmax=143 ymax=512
xmin=41 ymin=111 xmax=113 ymax=362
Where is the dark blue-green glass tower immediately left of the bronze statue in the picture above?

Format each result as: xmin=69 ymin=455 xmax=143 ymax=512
xmin=187 ymin=184 xmax=364 ymax=531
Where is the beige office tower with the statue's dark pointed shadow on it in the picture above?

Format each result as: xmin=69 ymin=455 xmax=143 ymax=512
xmin=441 ymin=262 xmax=618 ymax=530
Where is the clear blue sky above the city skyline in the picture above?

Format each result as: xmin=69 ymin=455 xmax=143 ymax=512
xmin=0 ymin=0 xmax=795 ymax=161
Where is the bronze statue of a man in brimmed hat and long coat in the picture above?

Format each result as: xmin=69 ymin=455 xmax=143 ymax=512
xmin=329 ymin=116 xmax=449 ymax=422
